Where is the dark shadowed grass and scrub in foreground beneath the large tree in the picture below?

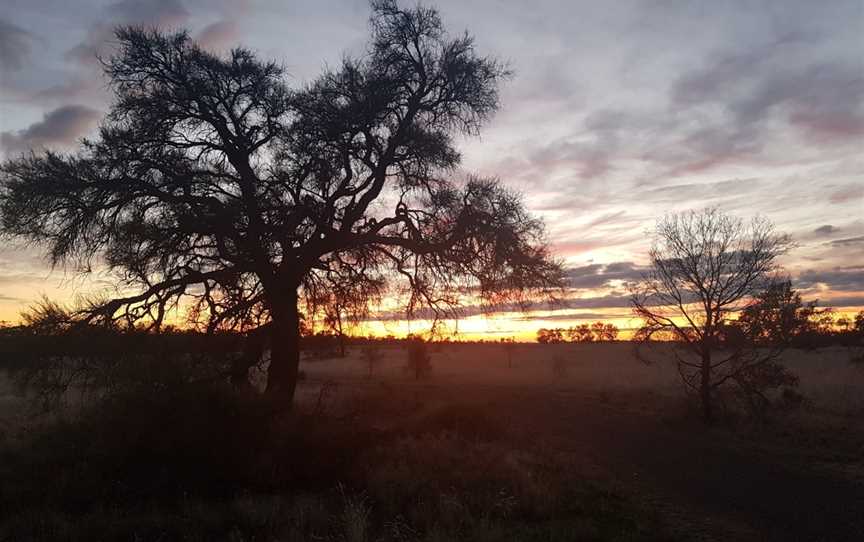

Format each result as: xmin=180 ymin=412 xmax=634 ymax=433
xmin=0 ymin=383 xmax=662 ymax=542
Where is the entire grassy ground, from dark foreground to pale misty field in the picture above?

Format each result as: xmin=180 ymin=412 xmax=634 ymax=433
xmin=0 ymin=343 xmax=864 ymax=542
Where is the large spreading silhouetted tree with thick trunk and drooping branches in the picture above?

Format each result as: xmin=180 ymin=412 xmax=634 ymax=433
xmin=0 ymin=0 xmax=561 ymax=408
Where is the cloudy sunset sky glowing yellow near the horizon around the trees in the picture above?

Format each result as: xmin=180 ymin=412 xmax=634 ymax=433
xmin=0 ymin=0 xmax=864 ymax=337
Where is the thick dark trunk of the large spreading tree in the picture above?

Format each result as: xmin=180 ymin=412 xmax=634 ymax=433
xmin=266 ymin=289 xmax=300 ymax=408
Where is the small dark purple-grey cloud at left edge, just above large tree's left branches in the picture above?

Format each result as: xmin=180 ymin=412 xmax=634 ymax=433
xmin=0 ymin=105 xmax=100 ymax=156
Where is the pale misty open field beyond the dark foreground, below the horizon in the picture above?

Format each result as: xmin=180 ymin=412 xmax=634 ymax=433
xmin=301 ymin=342 xmax=864 ymax=416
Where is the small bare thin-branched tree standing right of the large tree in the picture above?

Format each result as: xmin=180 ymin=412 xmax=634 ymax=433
xmin=631 ymin=209 xmax=790 ymax=422
